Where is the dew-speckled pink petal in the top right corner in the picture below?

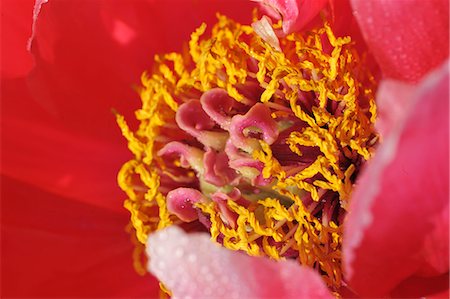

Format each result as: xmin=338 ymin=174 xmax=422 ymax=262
xmin=352 ymin=0 xmax=449 ymax=82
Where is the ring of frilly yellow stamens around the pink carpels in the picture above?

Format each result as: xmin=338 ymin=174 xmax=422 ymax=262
xmin=116 ymin=15 xmax=376 ymax=292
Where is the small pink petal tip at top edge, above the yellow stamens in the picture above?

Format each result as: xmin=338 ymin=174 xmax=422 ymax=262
xmin=258 ymin=0 xmax=329 ymax=34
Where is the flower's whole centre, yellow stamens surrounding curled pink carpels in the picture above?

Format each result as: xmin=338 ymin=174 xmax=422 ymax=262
xmin=117 ymin=16 xmax=377 ymax=288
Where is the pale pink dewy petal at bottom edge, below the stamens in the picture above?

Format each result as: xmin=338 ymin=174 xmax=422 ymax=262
xmin=147 ymin=226 xmax=333 ymax=299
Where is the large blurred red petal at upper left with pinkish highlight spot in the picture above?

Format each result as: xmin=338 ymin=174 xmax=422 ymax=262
xmin=2 ymin=0 xmax=251 ymax=210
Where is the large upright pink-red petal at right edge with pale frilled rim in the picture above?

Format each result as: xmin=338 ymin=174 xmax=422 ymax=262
xmin=343 ymin=62 xmax=449 ymax=297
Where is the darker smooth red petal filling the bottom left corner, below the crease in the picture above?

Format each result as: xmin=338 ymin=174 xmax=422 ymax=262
xmin=1 ymin=176 xmax=159 ymax=298
